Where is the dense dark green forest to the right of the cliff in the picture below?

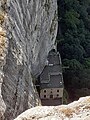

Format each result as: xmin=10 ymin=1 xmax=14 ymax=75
xmin=57 ymin=0 xmax=90 ymax=88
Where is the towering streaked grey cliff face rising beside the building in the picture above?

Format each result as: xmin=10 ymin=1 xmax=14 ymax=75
xmin=0 ymin=0 xmax=57 ymax=120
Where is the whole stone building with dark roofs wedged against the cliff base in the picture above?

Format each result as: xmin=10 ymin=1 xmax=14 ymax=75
xmin=40 ymin=50 xmax=64 ymax=105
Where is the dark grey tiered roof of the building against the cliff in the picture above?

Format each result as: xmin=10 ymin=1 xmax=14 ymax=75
xmin=40 ymin=51 xmax=63 ymax=88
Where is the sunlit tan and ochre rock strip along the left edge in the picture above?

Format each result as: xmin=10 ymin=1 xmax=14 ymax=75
xmin=0 ymin=0 xmax=8 ymax=120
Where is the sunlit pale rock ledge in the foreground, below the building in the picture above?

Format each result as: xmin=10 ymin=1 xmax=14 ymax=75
xmin=14 ymin=96 xmax=90 ymax=120
